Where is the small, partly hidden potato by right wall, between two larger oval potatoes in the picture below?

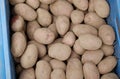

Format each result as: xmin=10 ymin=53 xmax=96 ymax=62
xmin=101 ymin=44 xmax=114 ymax=56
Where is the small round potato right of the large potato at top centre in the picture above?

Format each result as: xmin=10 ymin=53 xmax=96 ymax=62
xmin=70 ymin=10 xmax=84 ymax=24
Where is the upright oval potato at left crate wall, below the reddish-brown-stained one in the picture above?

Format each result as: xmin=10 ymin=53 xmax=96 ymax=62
xmin=11 ymin=32 xmax=27 ymax=57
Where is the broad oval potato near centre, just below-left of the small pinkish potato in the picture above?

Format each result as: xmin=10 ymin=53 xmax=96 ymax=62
xmin=48 ymin=43 xmax=71 ymax=61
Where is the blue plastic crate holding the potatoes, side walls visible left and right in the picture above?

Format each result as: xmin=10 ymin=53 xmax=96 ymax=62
xmin=0 ymin=0 xmax=120 ymax=79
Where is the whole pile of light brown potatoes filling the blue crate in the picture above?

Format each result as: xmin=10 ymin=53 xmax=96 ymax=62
xmin=9 ymin=0 xmax=119 ymax=79
